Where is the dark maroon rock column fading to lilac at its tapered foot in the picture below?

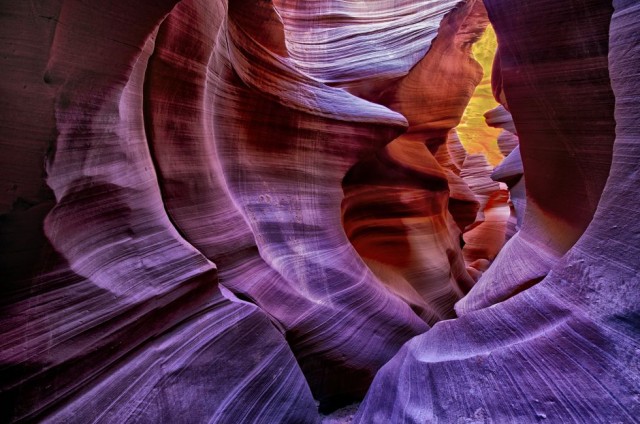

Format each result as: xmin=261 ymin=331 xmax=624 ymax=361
xmin=456 ymin=3 xmax=615 ymax=315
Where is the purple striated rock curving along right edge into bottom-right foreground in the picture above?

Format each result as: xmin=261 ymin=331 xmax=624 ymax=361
xmin=354 ymin=0 xmax=640 ymax=423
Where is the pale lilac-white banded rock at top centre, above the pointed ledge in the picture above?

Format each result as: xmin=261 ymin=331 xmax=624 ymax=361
xmin=274 ymin=0 xmax=463 ymax=99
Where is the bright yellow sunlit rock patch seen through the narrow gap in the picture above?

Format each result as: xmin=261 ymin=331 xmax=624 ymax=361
xmin=457 ymin=25 xmax=503 ymax=166
